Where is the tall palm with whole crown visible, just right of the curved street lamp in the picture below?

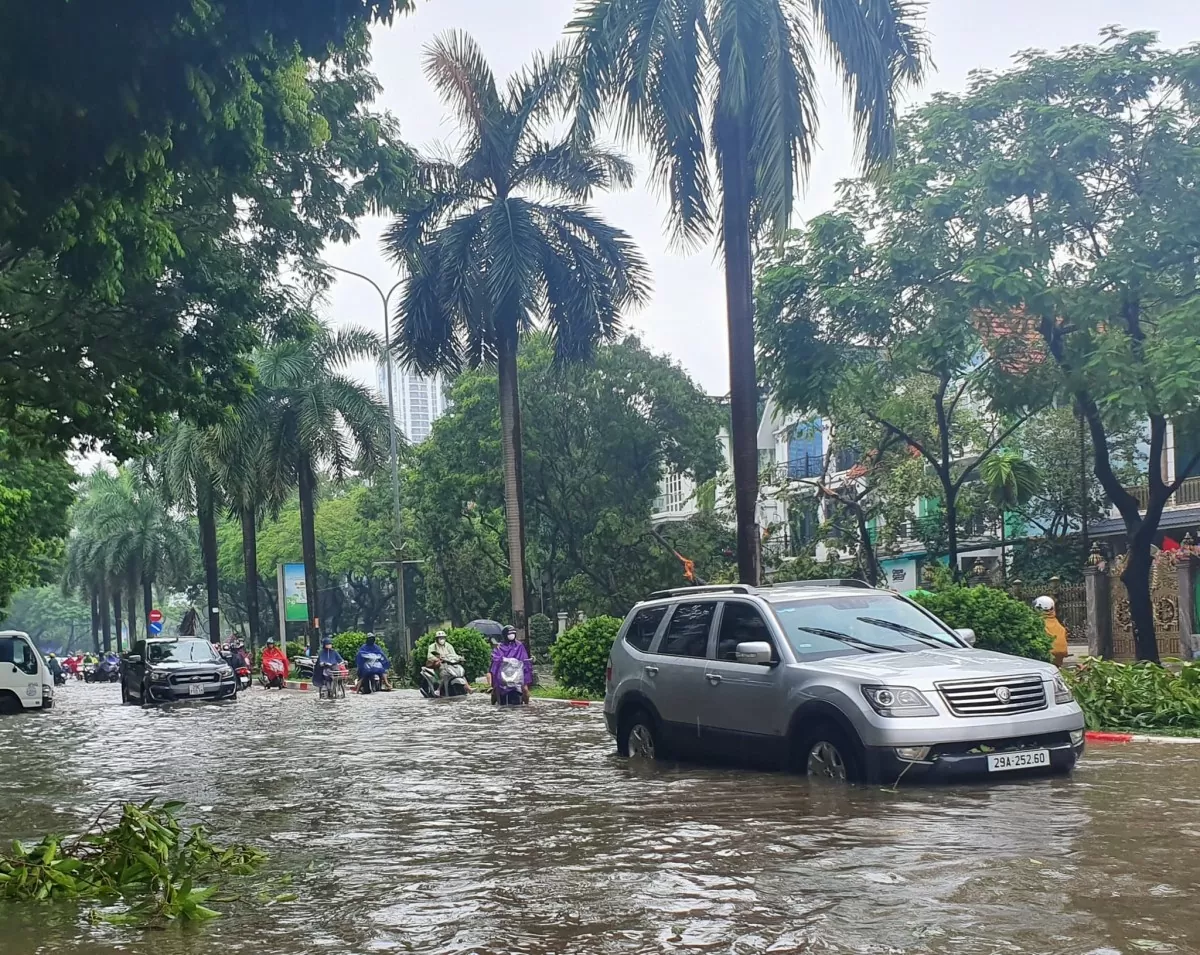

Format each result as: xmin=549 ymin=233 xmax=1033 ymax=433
xmin=384 ymin=32 xmax=648 ymax=627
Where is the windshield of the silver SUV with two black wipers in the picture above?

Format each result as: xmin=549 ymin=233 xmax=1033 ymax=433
xmin=770 ymin=593 xmax=962 ymax=659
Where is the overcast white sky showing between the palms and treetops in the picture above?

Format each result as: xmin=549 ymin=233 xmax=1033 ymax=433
xmin=326 ymin=0 xmax=1200 ymax=394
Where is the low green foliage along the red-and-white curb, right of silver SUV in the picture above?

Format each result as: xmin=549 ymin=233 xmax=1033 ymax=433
xmin=1063 ymin=657 xmax=1200 ymax=729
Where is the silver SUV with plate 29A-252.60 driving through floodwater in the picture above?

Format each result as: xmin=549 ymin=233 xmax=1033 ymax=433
xmin=604 ymin=581 xmax=1084 ymax=782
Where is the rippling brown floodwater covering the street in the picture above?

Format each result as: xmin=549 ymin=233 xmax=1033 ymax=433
xmin=0 ymin=684 xmax=1200 ymax=955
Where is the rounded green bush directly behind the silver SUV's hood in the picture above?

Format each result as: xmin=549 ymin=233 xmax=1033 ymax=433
xmin=913 ymin=587 xmax=1050 ymax=661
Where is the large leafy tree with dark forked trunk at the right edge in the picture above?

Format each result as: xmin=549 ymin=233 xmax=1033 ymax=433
xmin=883 ymin=28 xmax=1200 ymax=661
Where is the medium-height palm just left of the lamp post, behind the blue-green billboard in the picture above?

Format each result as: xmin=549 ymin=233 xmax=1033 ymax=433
xmin=255 ymin=324 xmax=391 ymax=635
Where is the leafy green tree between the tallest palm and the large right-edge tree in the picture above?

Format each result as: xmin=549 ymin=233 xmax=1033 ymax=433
xmin=758 ymin=194 xmax=1049 ymax=575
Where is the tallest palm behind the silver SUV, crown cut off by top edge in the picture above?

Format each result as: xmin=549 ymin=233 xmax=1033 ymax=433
xmin=569 ymin=0 xmax=925 ymax=583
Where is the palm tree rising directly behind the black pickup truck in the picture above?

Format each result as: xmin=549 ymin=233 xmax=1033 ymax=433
xmin=156 ymin=419 xmax=223 ymax=639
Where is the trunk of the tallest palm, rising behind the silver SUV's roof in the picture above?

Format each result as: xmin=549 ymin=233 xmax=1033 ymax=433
xmin=718 ymin=116 xmax=761 ymax=584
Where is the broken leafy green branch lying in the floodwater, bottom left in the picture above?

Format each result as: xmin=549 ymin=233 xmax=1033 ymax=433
xmin=0 ymin=800 xmax=266 ymax=925
